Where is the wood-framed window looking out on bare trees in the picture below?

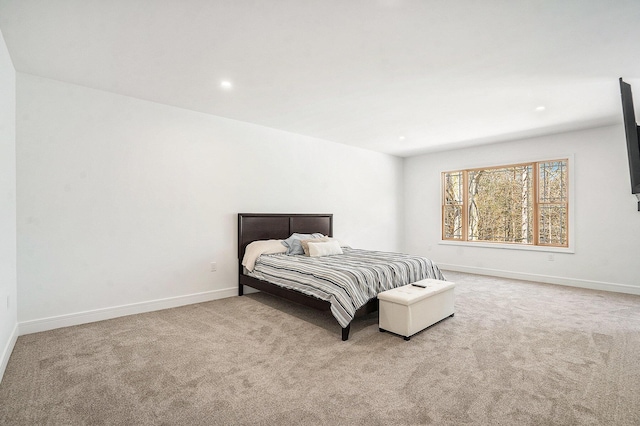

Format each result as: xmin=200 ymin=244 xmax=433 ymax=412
xmin=442 ymin=159 xmax=569 ymax=247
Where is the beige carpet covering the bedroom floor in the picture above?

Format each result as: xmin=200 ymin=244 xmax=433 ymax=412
xmin=0 ymin=273 xmax=640 ymax=425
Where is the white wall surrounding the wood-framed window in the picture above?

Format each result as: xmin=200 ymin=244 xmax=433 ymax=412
xmin=404 ymin=124 xmax=640 ymax=294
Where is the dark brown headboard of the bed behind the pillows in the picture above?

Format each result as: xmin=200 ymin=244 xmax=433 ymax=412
xmin=238 ymin=213 xmax=333 ymax=260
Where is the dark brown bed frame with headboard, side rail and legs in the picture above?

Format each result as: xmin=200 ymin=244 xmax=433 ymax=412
xmin=238 ymin=213 xmax=378 ymax=340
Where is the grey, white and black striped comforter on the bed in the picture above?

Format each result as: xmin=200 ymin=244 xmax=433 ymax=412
xmin=250 ymin=247 xmax=445 ymax=327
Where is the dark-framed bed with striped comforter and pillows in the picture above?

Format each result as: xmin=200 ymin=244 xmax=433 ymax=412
xmin=238 ymin=213 xmax=444 ymax=340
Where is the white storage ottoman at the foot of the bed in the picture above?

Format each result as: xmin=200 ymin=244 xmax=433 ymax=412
xmin=378 ymin=279 xmax=455 ymax=340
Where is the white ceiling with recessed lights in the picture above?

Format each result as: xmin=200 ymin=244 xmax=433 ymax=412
xmin=0 ymin=0 xmax=640 ymax=156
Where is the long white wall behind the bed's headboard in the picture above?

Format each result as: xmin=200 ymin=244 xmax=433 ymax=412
xmin=17 ymin=73 xmax=402 ymax=334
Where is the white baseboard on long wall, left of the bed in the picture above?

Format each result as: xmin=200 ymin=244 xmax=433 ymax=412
xmin=18 ymin=287 xmax=238 ymax=336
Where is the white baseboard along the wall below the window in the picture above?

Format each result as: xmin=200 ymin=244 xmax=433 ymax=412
xmin=438 ymin=263 xmax=640 ymax=295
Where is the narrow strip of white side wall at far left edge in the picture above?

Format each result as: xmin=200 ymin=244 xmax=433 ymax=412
xmin=0 ymin=33 xmax=18 ymax=380
